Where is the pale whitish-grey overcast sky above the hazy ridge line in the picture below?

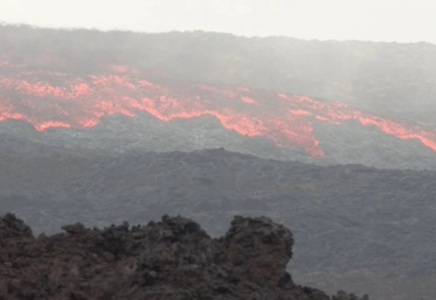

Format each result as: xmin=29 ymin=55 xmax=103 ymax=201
xmin=0 ymin=0 xmax=436 ymax=44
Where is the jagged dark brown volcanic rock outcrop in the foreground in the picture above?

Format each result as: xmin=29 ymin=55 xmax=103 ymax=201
xmin=0 ymin=214 xmax=368 ymax=300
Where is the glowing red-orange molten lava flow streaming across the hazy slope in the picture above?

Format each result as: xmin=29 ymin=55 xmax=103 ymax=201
xmin=0 ymin=59 xmax=436 ymax=156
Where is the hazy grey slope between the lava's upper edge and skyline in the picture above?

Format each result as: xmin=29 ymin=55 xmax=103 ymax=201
xmin=0 ymin=26 xmax=436 ymax=126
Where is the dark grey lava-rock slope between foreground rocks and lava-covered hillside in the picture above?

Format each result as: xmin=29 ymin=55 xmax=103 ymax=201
xmin=0 ymin=145 xmax=436 ymax=300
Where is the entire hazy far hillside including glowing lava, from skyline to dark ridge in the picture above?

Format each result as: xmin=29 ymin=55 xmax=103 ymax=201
xmin=0 ymin=26 xmax=436 ymax=170
